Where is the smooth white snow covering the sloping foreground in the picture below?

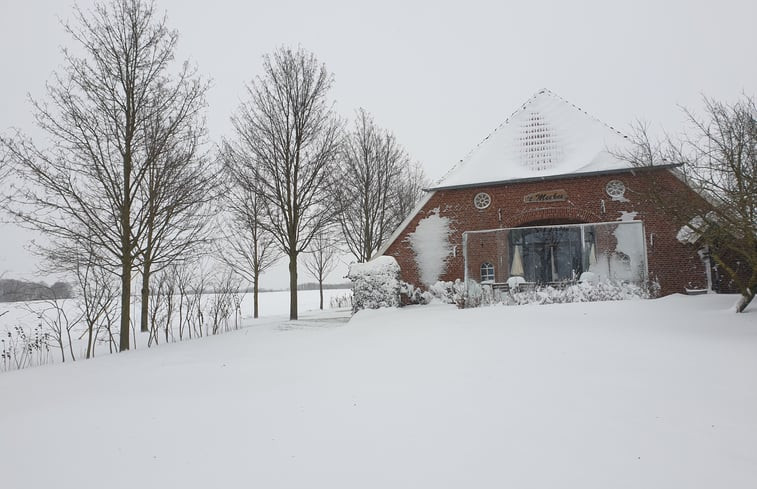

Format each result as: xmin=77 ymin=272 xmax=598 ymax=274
xmin=0 ymin=295 xmax=757 ymax=489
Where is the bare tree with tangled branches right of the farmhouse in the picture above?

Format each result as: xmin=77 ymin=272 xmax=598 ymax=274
xmin=622 ymin=96 xmax=757 ymax=312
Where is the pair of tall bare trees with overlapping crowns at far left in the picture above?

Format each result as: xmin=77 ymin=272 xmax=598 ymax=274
xmin=2 ymin=0 xmax=218 ymax=350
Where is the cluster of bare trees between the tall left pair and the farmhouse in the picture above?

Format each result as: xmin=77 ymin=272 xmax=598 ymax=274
xmin=222 ymin=48 xmax=424 ymax=319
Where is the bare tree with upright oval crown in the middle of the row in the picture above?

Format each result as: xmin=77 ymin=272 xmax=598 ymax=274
xmin=227 ymin=48 xmax=340 ymax=319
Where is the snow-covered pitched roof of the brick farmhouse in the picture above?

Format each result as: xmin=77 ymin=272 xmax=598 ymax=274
xmin=433 ymin=89 xmax=632 ymax=189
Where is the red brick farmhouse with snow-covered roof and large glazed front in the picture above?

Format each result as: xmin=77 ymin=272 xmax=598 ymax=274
xmin=379 ymin=90 xmax=711 ymax=294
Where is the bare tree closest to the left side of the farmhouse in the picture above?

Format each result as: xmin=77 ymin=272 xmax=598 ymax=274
xmin=334 ymin=109 xmax=424 ymax=262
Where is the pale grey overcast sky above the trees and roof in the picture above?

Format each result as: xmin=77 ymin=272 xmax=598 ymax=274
xmin=0 ymin=0 xmax=757 ymax=287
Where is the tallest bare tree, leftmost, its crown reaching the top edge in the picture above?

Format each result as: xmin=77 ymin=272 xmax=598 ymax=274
xmin=3 ymin=0 xmax=211 ymax=350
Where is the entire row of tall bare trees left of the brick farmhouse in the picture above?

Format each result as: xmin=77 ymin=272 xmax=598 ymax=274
xmin=0 ymin=0 xmax=423 ymax=346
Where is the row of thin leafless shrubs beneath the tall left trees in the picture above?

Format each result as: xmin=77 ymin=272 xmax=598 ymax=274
xmin=0 ymin=262 xmax=243 ymax=371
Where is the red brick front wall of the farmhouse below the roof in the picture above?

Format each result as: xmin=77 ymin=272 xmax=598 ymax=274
xmin=385 ymin=170 xmax=706 ymax=295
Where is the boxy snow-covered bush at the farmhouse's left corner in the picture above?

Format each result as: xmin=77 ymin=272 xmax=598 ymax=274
xmin=347 ymin=256 xmax=400 ymax=313
